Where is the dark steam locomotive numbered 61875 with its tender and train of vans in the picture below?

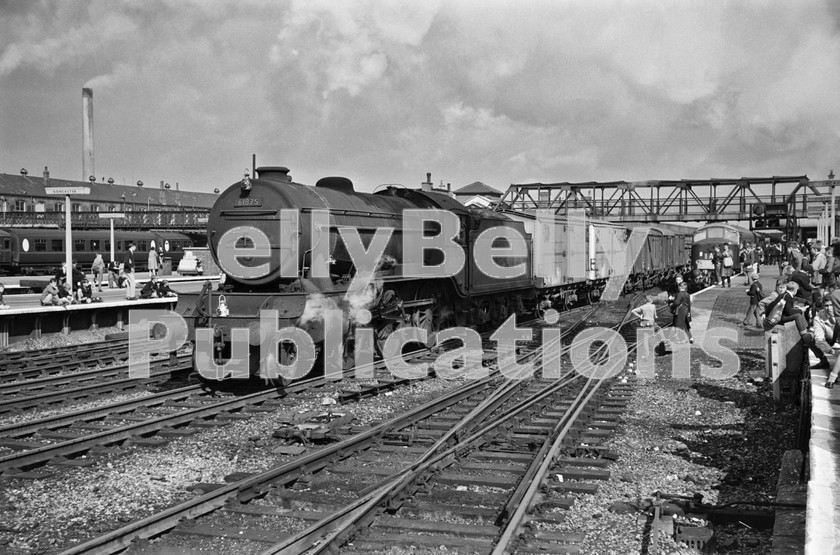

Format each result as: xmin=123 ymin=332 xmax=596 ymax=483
xmin=178 ymin=167 xmax=687 ymax=382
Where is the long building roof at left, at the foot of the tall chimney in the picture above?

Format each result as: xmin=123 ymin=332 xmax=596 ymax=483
xmin=0 ymin=173 xmax=216 ymax=209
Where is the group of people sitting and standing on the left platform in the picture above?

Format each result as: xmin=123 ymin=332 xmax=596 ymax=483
xmin=37 ymin=243 xmax=176 ymax=306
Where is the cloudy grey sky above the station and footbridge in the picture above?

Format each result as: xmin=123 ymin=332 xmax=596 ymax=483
xmin=0 ymin=0 xmax=840 ymax=192
